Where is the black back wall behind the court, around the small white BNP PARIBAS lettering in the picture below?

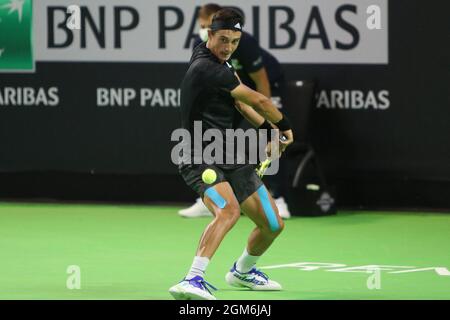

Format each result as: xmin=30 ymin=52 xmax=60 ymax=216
xmin=0 ymin=1 xmax=450 ymax=209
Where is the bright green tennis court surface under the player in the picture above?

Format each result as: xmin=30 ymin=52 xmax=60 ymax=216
xmin=0 ymin=202 xmax=450 ymax=300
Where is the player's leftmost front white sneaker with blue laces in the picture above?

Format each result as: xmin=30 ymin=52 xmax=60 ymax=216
xmin=169 ymin=276 xmax=217 ymax=300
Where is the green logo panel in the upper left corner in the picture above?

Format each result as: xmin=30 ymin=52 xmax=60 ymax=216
xmin=0 ymin=0 xmax=34 ymax=72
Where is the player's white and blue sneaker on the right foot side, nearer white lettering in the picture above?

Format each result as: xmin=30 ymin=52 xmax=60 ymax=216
xmin=225 ymin=263 xmax=282 ymax=291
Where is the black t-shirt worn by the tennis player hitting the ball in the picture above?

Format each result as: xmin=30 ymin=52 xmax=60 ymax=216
xmin=180 ymin=43 xmax=240 ymax=168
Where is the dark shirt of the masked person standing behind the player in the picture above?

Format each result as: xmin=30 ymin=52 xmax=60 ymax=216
xmin=194 ymin=32 xmax=283 ymax=89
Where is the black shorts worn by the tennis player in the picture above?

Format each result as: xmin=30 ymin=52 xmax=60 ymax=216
xmin=179 ymin=164 xmax=263 ymax=203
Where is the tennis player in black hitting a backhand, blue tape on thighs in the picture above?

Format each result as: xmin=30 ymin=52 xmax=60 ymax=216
xmin=169 ymin=8 xmax=293 ymax=300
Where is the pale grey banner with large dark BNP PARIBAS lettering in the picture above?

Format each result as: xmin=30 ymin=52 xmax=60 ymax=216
xmin=26 ymin=0 xmax=389 ymax=64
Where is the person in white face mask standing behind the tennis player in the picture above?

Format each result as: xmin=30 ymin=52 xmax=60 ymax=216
xmin=178 ymin=3 xmax=291 ymax=219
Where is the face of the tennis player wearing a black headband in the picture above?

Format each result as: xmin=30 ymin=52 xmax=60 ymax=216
xmin=208 ymin=30 xmax=242 ymax=62
